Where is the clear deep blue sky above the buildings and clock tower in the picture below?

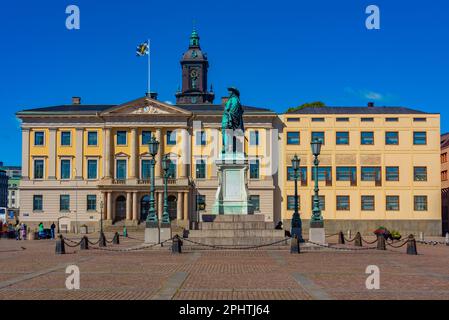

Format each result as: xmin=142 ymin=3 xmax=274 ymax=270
xmin=0 ymin=0 xmax=449 ymax=165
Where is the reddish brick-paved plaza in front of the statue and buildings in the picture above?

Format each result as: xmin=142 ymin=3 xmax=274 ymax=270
xmin=0 ymin=234 xmax=449 ymax=300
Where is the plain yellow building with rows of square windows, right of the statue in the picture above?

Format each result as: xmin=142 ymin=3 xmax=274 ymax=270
xmin=279 ymin=104 xmax=441 ymax=235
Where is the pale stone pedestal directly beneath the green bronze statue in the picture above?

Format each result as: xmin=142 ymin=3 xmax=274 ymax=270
xmin=212 ymin=153 xmax=252 ymax=215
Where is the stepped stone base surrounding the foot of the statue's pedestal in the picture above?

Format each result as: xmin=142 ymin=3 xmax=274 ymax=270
xmin=184 ymin=215 xmax=289 ymax=249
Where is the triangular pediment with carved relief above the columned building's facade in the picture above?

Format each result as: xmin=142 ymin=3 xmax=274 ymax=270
xmin=102 ymin=97 xmax=190 ymax=116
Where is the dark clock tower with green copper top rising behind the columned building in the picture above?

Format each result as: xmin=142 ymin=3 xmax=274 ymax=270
xmin=176 ymin=29 xmax=215 ymax=104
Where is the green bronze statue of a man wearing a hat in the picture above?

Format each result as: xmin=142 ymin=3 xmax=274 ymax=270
xmin=221 ymin=87 xmax=245 ymax=153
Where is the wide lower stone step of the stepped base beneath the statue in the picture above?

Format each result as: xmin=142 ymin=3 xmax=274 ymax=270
xmin=189 ymin=229 xmax=285 ymax=238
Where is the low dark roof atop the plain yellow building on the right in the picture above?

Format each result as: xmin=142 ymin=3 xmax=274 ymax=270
xmin=287 ymin=107 xmax=428 ymax=115
